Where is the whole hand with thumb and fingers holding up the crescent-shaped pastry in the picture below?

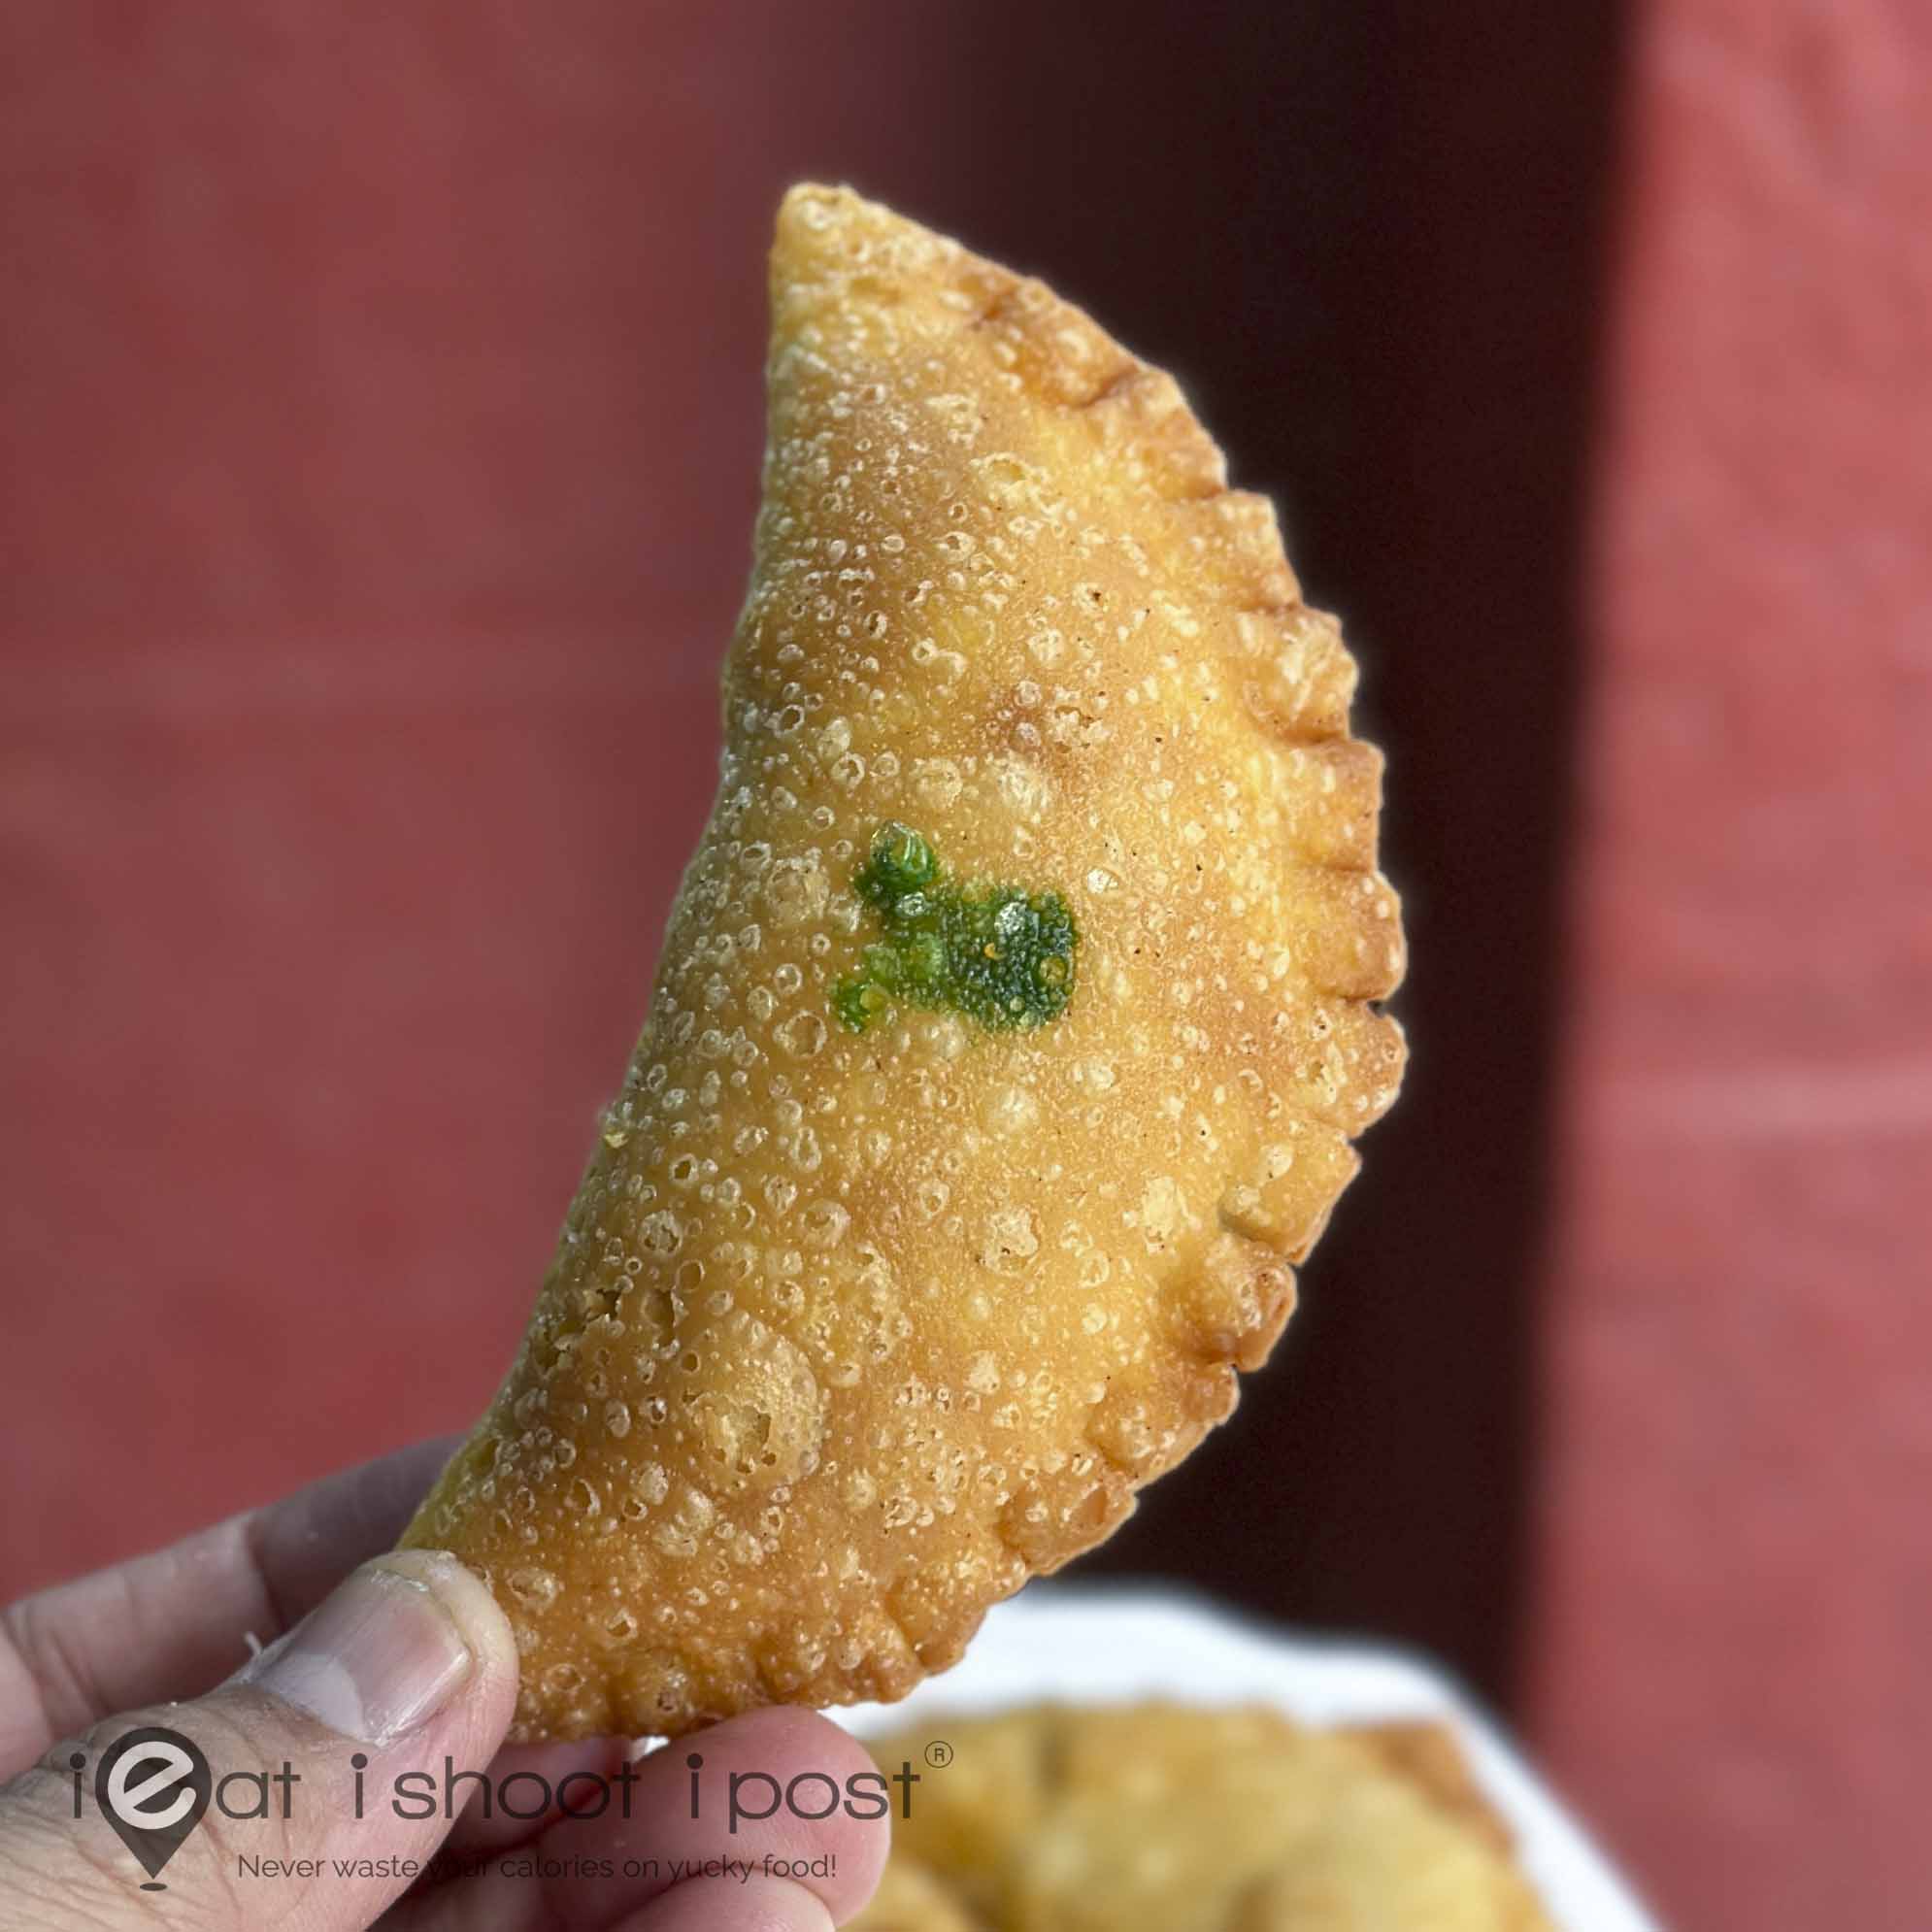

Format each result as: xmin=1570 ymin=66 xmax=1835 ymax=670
xmin=0 ymin=1444 xmax=888 ymax=1932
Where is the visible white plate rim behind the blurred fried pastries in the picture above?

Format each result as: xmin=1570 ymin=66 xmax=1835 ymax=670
xmin=827 ymin=1584 xmax=1659 ymax=1932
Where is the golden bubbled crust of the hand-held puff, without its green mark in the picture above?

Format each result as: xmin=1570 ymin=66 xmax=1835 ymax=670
xmin=408 ymin=187 xmax=1403 ymax=1739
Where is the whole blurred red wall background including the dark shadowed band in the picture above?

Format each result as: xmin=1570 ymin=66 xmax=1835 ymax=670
xmin=0 ymin=0 xmax=1932 ymax=1932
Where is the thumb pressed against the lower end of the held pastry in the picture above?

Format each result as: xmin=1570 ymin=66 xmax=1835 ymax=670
xmin=0 ymin=1549 xmax=516 ymax=1932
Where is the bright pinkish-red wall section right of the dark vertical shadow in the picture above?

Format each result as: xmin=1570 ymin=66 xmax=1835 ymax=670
xmin=1528 ymin=0 xmax=1932 ymax=1932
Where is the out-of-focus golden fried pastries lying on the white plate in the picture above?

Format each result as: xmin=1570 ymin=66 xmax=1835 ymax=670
xmin=852 ymin=1704 xmax=1551 ymax=1932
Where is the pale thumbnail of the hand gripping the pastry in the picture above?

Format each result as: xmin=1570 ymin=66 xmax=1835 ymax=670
xmin=240 ymin=1553 xmax=474 ymax=1745
